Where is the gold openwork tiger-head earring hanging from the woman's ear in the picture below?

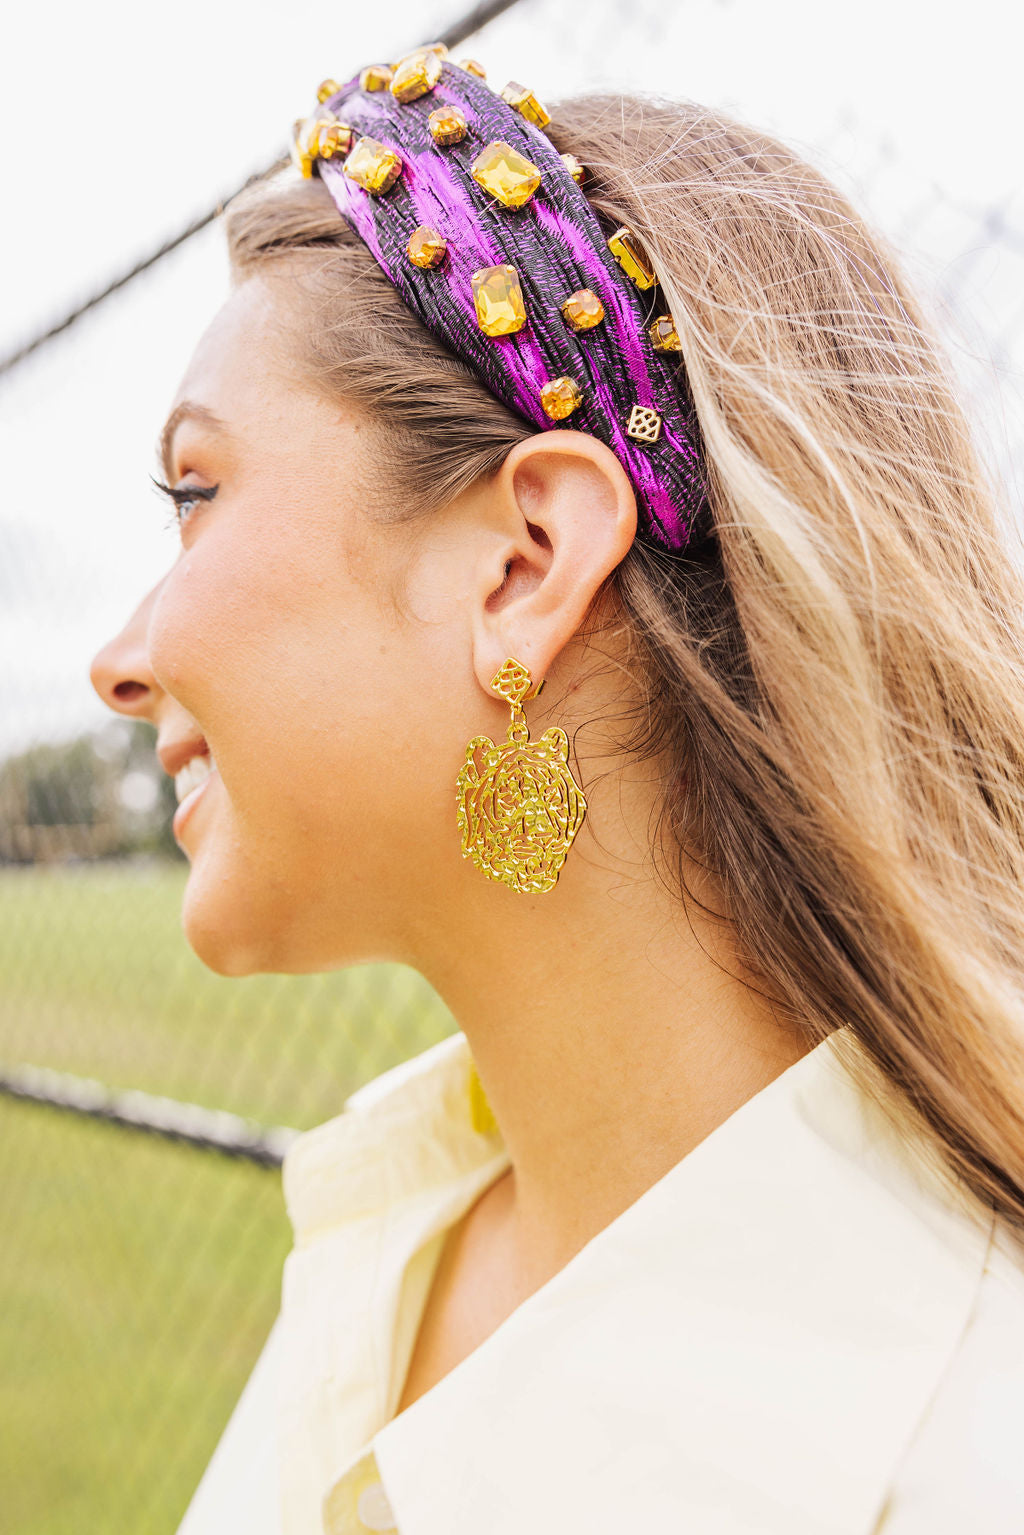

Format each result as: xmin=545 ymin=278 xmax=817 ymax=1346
xmin=456 ymin=655 xmax=586 ymax=893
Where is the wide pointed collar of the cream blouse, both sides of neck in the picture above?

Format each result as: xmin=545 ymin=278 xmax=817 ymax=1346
xmin=286 ymin=1030 xmax=990 ymax=1535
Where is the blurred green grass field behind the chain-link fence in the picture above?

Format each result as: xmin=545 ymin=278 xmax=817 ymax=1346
xmin=0 ymin=864 xmax=453 ymax=1535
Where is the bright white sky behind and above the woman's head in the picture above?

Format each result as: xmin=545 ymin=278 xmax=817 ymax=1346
xmin=0 ymin=0 xmax=1024 ymax=755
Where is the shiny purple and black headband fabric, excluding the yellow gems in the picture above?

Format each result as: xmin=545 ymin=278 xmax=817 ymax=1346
xmin=316 ymin=60 xmax=705 ymax=550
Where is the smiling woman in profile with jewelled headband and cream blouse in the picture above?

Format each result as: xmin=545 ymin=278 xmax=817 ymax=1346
xmin=92 ymin=48 xmax=1024 ymax=1535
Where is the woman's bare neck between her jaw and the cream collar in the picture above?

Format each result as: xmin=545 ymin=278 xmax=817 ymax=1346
xmin=413 ymin=684 xmax=808 ymax=1274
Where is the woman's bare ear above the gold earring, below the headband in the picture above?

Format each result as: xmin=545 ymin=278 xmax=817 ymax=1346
xmin=473 ymin=430 xmax=637 ymax=691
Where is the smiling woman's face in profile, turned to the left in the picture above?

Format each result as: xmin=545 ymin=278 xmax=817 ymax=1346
xmin=91 ymin=276 xmax=488 ymax=975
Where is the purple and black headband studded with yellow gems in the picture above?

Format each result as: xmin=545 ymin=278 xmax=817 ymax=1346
xmin=292 ymin=43 xmax=706 ymax=550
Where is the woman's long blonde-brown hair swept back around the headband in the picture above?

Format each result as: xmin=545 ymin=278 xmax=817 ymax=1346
xmin=226 ymin=95 xmax=1024 ymax=1234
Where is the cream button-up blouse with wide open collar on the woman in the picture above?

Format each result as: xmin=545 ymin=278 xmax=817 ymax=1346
xmin=180 ymin=1035 xmax=1024 ymax=1535
